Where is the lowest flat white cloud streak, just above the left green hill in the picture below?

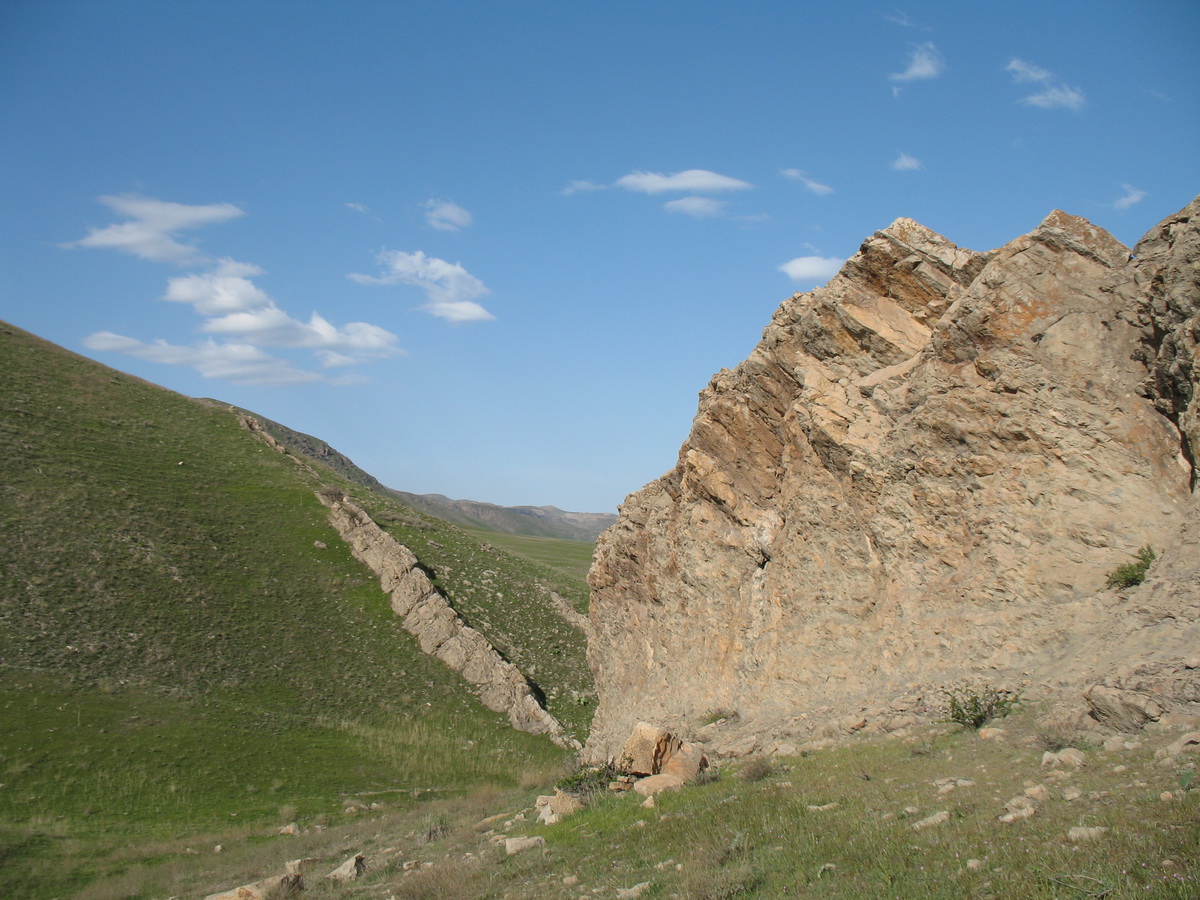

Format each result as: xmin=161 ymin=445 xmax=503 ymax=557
xmin=84 ymin=331 xmax=322 ymax=386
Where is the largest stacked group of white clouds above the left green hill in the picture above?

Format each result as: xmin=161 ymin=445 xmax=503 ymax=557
xmin=67 ymin=197 xmax=401 ymax=385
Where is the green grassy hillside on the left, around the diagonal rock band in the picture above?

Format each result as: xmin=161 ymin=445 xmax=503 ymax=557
xmin=0 ymin=324 xmax=590 ymax=898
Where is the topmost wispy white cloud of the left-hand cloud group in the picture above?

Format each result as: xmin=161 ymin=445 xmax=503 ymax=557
xmin=62 ymin=194 xmax=245 ymax=265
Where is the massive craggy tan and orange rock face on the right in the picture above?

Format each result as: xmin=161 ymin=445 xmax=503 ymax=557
xmin=587 ymin=196 xmax=1200 ymax=760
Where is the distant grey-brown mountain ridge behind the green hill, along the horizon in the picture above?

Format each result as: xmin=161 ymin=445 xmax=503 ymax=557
xmin=204 ymin=408 xmax=617 ymax=544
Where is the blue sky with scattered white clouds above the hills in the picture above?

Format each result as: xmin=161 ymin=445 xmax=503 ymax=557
xmin=0 ymin=0 xmax=1200 ymax=511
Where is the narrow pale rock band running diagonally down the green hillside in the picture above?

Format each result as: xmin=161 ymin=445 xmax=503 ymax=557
xmin=317 ymin=491 xmax=578 ymax=746
